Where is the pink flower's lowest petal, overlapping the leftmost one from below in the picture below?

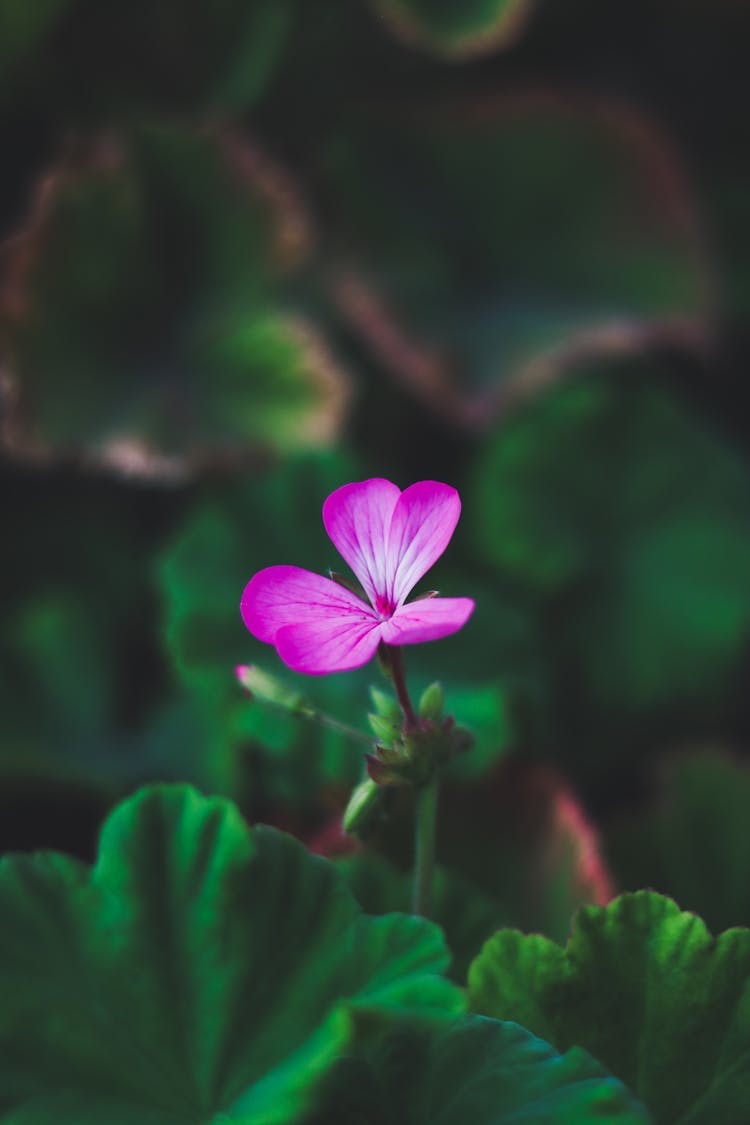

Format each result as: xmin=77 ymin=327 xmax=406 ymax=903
xmin=275 ymin=614 xmax=382 ymax=676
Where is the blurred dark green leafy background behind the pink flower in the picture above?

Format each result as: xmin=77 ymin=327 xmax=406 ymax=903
xmin=0 ymin=0 xmax=750 ymax=950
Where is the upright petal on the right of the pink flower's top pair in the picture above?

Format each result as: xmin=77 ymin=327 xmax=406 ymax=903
xmin=387 ymin=480 xmax=463 ymax=607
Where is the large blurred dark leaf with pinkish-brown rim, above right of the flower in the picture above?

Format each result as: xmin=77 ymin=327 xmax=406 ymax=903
xmin=316 ymin=96 xmax=712 ymax=428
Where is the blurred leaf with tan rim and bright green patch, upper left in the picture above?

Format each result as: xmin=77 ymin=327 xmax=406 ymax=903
xmin=0 ymin=125 xmax=347 ymax=478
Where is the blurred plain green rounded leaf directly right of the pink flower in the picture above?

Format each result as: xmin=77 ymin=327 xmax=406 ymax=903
xmin=468 ymin=366 xmax=750 ymax=781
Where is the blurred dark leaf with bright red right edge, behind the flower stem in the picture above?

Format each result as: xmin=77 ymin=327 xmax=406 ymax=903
xmin=339 ymin=758 xmax=614 ymax=981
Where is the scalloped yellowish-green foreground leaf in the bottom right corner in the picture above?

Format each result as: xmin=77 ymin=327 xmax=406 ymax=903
xmin=469 ymin=891 xmax=750 ymax=1125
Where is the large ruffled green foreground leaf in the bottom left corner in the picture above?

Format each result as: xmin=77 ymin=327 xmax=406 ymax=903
xmin=0 ymin=788 xmax=461 ymax=1125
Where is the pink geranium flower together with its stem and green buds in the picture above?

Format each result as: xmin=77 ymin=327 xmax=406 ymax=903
xmin=240 ymin=477 xmax=475 ymax=912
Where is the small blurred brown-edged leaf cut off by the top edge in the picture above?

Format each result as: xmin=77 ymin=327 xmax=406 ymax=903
xmin=371 ymin=0 xmax=532 ymax=59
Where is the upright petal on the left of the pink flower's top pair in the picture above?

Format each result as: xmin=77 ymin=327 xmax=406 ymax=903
xmin=323 ymin=477 xmax=401 ymax=605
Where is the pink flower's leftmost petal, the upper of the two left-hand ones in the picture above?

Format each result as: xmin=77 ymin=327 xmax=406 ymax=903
xmin=240 ymin=566 xmax=377 ymax=645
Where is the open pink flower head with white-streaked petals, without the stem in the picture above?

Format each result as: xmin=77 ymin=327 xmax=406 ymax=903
xmin=241 ymin=477 xmax=475 ymax=675
